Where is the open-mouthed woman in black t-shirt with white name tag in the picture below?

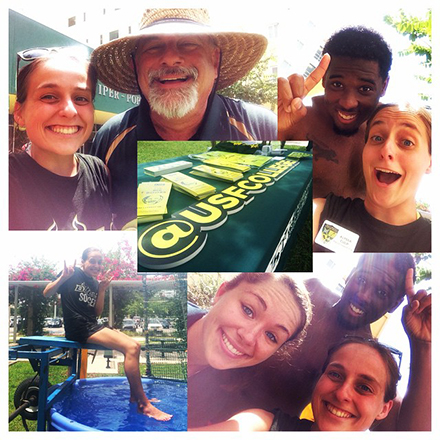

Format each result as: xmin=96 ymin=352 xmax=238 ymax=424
xmin=313 ymin=104 xmax=431 ymax=252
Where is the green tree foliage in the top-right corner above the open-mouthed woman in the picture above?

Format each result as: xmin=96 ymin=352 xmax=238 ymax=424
xmin=384 ymin=9 xmax=432 ymax=101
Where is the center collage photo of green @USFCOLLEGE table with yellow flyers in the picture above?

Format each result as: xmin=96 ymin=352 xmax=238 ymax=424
xmin=137 ymin=141 xmax=312 ymax=272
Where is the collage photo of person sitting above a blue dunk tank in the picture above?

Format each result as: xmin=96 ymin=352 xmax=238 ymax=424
xmin=8 ymin=232 xmax=187 ymax=431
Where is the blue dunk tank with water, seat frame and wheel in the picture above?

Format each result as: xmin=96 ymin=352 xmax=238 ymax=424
xmin=9 ymin=336 xmax=187 ymax=431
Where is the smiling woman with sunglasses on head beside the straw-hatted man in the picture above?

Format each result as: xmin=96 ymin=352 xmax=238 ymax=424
xmin=9 ymin=49 xmax=111 ymax=230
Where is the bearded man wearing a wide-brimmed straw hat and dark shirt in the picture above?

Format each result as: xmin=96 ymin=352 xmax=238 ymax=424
xmin=92 ymin=9 xmax=277 ymax=229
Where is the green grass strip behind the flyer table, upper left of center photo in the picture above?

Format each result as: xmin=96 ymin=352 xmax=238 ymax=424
xmin=138 ymin=141 xmax=211 ymax=163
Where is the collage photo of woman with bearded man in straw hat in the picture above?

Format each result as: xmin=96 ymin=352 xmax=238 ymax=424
xmin=8 ymin=3 xmax=277 ymax=230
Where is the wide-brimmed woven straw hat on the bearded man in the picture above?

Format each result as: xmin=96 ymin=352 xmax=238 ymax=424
xmin=91 ymin=9 xmax=267 ymax=94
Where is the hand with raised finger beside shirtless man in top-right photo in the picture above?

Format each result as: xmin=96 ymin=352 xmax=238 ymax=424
xmin=278 ymin=54 xmax=330 ymax=132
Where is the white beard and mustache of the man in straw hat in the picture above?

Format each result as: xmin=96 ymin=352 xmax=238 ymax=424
xmin=146 ymin=67 xmax=199 ymax=119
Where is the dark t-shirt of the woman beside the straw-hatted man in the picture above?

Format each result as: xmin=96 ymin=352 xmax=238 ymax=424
xmin=9 ymin=152 xmax=112 ymax=231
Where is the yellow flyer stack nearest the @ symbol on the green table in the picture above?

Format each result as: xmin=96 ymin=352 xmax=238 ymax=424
xmin=138 ymin=182 xmax=172 ymax=223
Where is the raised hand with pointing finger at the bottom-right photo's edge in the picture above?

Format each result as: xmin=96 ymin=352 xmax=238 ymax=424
xmin=402 ymin=269 xmax=431 ymax=342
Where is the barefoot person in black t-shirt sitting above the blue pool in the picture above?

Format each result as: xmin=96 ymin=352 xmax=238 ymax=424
xmin=43 ymin=248 xmax=172 ymax=421
